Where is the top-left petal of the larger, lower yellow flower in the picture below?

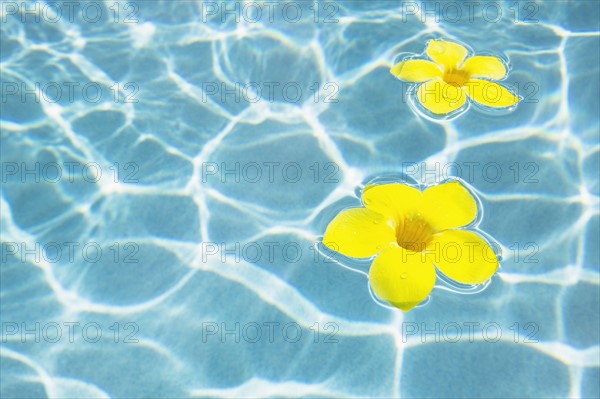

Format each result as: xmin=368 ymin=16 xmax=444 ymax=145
xmin=362 ymin=183 xmax=423 ymax=221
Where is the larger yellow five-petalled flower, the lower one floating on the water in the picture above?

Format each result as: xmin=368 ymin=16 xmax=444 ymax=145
xmin=323 ymin=181 xmax=498 ymax=312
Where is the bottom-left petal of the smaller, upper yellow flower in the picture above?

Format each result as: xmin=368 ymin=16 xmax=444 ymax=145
xmin=417 ymin=78 xmax=467 ymax=115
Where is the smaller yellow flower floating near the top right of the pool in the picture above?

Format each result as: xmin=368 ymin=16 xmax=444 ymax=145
xmin=390 ymin=40 xmax=520 ymax=115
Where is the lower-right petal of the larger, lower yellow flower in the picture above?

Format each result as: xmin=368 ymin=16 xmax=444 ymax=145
xmin=427 ymin=230 xmax=498 ymax=284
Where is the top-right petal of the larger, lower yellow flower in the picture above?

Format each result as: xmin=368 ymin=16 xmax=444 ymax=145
xmin=423 ymin=181 xmax=477 ymax=231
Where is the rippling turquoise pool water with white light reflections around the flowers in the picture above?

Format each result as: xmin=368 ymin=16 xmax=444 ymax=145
xmin=0 ymin=1 xmax=600 ymax=398
